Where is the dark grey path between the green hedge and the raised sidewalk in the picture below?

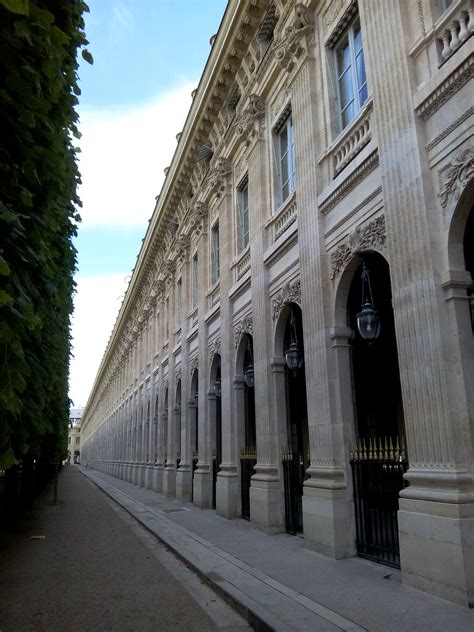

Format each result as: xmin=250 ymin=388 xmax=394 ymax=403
xmin=0 ymin=465 xmax=250 ymax=632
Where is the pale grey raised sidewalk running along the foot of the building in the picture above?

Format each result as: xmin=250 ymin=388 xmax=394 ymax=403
xmin=81 ymin=467 xmax=474 ymax=632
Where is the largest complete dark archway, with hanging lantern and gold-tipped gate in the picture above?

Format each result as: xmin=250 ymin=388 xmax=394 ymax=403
xmin=347 ymin=253 xmax=408 ymax=567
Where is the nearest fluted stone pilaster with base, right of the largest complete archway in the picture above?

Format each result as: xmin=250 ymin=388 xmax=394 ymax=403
xmin=359 ymin=0 xmax=474 ymax=603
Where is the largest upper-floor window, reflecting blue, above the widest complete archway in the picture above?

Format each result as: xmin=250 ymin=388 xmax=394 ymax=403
xmin=334 ymin=19 xmax=367 ymax=129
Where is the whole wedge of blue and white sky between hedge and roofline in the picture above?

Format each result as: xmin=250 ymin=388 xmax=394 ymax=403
xmin=69 ymin=0 xmax=226 ymax=407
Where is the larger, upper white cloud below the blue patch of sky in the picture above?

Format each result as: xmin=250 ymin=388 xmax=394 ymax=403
xmin=79 ymin=83 xmax=195 ymax=226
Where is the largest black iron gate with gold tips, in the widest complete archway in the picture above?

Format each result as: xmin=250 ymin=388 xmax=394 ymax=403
xmin=351 ymin=438 xmax=408 ymax=568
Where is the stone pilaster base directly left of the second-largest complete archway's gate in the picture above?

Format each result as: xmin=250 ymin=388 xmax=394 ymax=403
xmin=250 ymin=474 xmax=285 ymax=533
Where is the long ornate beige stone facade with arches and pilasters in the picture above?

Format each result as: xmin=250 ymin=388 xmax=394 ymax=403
xmin=81 ymin=0 xmax=474 ymax=605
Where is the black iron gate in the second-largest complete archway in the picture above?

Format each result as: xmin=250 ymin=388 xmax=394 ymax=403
xmin=282 ymin=452 xmax=306 ymax=535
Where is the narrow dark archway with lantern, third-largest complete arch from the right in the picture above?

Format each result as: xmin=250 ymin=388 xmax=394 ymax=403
xmin=237 ymin=333 xmax=257 ymax=520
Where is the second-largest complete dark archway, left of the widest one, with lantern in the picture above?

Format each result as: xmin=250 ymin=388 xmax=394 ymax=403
xmin=283 ymin=303 xmax=309 ymax=534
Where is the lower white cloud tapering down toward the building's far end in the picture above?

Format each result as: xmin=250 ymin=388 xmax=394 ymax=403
xmin=69 ymin=274 xmax=129 ymax=407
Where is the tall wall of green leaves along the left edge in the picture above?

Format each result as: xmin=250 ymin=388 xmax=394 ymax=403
xmin=0 ymin=0 xmax=92 ymax=469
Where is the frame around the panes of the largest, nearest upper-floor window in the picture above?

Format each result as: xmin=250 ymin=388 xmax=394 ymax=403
xmin=332 ymin=13 xmax=369 ymax=132
